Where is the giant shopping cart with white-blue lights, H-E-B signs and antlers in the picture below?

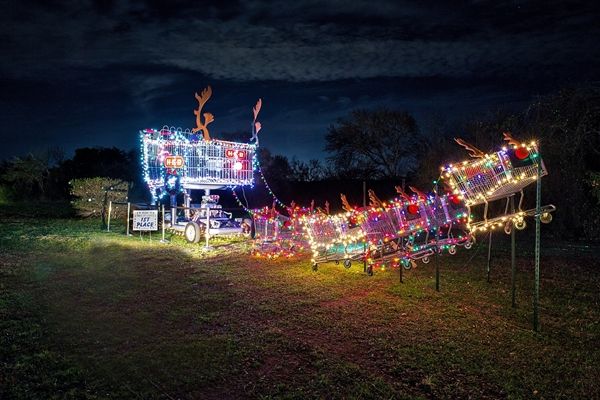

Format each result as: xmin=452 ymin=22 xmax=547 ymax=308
xmin=140 ymin=86 xmax=262 ymax=243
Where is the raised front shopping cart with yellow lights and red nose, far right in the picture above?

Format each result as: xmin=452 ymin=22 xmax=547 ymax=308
xmin=442 ymin=133 xmax=556 ymax=233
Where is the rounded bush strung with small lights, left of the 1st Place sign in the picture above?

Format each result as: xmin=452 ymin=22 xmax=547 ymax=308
xmin=69 ymin=177 xmax=129 ymax=218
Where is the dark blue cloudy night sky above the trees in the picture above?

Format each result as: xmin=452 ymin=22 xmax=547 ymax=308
xmin=0 ymin=0 xmax=600 ymax=159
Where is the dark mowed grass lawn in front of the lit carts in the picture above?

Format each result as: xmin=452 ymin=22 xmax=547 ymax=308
xmin=0 ymin=212 xmax=600 ymax=399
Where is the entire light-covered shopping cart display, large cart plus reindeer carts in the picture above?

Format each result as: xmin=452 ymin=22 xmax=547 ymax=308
xmin=140 ymin=87 xmax=555 ymax=275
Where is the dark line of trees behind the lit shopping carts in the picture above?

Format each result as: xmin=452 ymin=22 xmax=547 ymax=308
xmin=0 ymin=84 xmax=600 ymax=238
